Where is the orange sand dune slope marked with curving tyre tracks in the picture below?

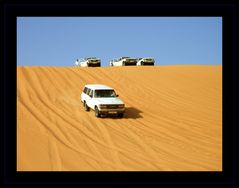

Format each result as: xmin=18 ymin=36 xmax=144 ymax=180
xmin=17 ymin=65 xmax=222 ymax=171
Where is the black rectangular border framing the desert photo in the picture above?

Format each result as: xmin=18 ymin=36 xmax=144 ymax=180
xmin=2 ymin=2 xmax=238 ymax=187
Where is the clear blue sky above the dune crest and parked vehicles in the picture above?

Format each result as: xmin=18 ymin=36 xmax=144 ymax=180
xmin=17 ymin=17 xmax=222 ymax=66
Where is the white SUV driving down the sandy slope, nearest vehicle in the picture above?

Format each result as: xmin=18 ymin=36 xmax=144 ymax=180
xmin=81 ymin=84 xmax=125 ymax=118
